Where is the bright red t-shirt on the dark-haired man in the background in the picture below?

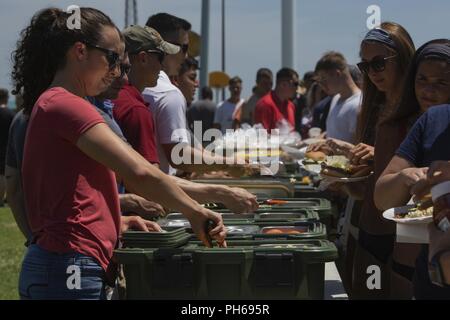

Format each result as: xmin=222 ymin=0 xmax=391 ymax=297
xmin=255 ymin=91 xmax=295 ymax=130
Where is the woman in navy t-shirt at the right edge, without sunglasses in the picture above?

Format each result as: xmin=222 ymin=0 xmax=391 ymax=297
xmin=375 ymin=39 xmax=450 ymax=299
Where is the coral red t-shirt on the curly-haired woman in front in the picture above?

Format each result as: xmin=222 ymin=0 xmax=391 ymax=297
xmin=22 ymin=88 xmax=120 ymax=270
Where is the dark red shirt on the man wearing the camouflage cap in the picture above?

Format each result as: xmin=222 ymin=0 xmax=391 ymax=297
xmin=113 ymin=83 xmax=159 ymax=163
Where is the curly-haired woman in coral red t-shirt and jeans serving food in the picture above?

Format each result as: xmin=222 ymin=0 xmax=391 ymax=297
xmin=12 ymin=8 xmax=226 ymax=299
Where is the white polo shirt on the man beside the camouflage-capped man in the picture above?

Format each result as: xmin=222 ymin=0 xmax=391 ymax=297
xmin=142 ymin=71 xmax=190 ymax=175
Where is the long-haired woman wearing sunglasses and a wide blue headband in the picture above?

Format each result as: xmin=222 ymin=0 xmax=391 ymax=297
xmin=344 ymin=22 xmax=414 ymax=299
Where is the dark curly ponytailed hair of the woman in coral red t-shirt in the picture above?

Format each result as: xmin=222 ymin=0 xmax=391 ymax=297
xmin=11 ymin=8 xmax=116 ymax=114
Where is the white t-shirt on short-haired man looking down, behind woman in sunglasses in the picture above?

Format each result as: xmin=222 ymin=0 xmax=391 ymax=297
xmin=327 ymin=91 xmax=362 ymax=143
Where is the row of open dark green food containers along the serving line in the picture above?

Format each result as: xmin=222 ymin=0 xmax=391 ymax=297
xmin=115 ymin=171 xmax=338 ymax=299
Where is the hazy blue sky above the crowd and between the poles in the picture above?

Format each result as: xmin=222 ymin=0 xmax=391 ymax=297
xmin=0 ymin=0 xmax=450 ymax=105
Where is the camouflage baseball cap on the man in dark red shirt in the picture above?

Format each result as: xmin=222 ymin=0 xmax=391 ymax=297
xmin=122 ymin=26 xmax=180 ymax=54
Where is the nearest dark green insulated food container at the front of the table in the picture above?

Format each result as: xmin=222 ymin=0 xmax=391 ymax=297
xmin=115 ymin=239 xmax=337 ymax=299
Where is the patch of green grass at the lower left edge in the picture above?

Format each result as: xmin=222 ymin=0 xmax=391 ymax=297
xmin=0 ymin=208 xmax=25 ymax=300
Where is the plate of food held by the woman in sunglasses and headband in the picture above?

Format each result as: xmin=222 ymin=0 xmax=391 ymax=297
xmin=320 ymin=156 xmax=373 ymax=183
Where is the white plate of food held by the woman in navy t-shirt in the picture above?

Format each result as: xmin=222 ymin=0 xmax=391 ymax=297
xmin=383 ymin=204 xmax=433 ymax=224
